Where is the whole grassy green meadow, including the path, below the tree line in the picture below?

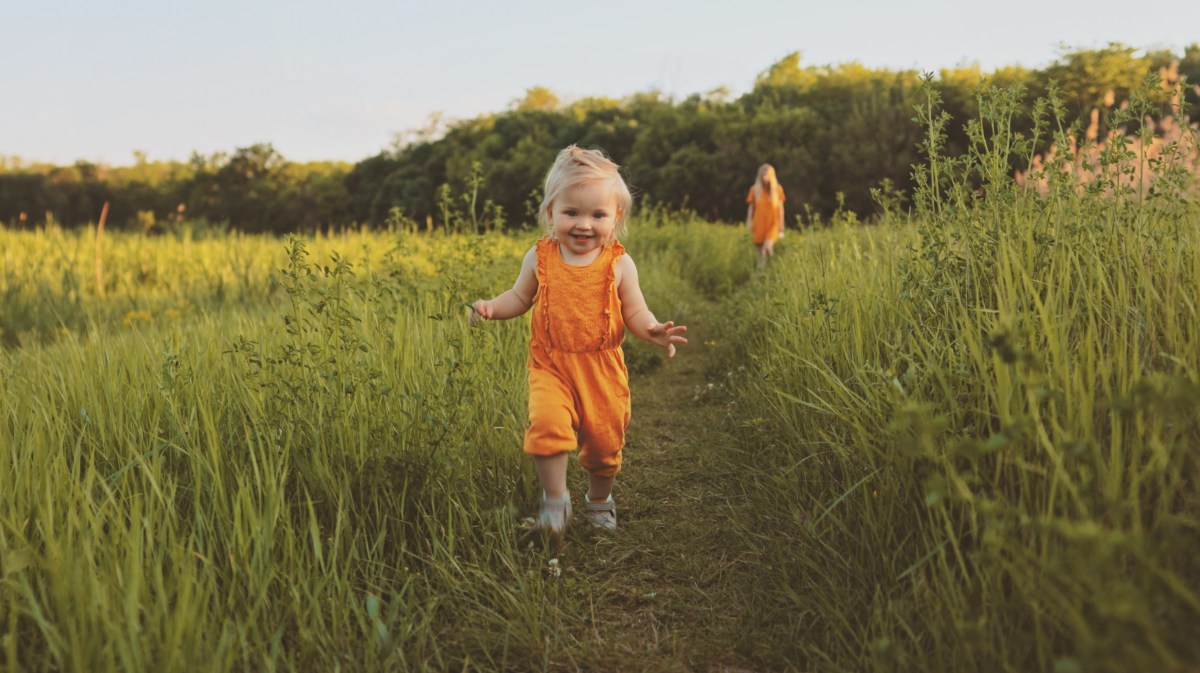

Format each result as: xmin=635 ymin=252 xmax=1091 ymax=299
xmin=0 ymin=81 xmax=1200 ymax=673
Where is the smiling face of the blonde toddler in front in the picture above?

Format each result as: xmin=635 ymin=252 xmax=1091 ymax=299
xmin=546 ymin=180 xmax=620 ymax=264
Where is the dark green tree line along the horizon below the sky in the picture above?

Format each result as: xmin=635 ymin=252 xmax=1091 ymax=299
xmin=0 ymin=44 xmax=1200 ymax=233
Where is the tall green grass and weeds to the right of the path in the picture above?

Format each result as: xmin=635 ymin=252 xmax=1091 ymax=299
xmin=722 ymin=77 xmax=1200 ymax=672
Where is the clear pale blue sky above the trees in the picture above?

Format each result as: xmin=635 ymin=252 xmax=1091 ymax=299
xmin=0 ymin=0 xmax=1200 ymax=164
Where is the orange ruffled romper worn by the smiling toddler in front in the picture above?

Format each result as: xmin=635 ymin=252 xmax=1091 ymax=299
xmin=524 ymin=238 xmax=630 ymax=476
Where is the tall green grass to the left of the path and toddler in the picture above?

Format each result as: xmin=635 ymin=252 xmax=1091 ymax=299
xmin=0 ymin=218 xmax=734 ymax=671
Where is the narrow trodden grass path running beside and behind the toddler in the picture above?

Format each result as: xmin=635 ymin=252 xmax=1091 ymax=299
xmin=540 ymin=298 xmax=755 ymax=673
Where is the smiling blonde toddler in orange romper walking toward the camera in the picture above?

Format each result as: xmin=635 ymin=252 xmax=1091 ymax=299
xmin=472 ymin=145 xmax=688 ymax=537
